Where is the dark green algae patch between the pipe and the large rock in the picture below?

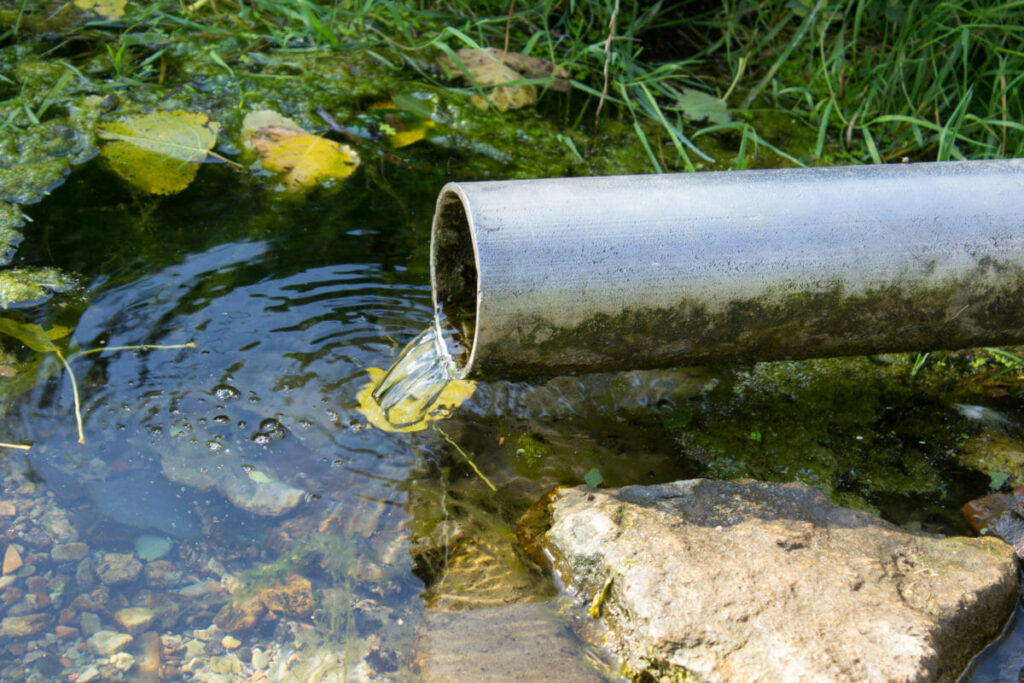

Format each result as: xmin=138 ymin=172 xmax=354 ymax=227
xmin=667 ymin=355 xmax=991 ymax=518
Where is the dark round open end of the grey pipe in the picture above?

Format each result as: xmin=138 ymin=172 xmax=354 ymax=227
xmin=430 ymin=189 xmax=477 ymax=379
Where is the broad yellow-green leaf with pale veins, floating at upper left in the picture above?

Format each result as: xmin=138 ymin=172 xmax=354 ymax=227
xmin=99 ymin=112 xmax=220 ymax=195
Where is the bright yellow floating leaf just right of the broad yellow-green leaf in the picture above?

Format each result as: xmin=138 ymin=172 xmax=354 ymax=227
xmin=250 ymin=126 xmax=359 ymax=191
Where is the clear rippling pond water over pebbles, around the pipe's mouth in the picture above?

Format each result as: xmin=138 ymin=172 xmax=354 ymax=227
xmin=0 ymin=158 xmax=1021 ymax=681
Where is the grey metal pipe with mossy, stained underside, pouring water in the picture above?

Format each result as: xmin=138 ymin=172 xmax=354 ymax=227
xmin=430 ymin=160 xmax=1024 ymax=379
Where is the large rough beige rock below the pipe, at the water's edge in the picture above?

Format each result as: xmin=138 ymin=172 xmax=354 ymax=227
xmin=546 ymin=479 xmax=1017 ymax=681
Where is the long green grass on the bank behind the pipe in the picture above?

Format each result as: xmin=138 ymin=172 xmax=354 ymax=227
xmin=0 ymin=0 xmax=1024 ymax=166
